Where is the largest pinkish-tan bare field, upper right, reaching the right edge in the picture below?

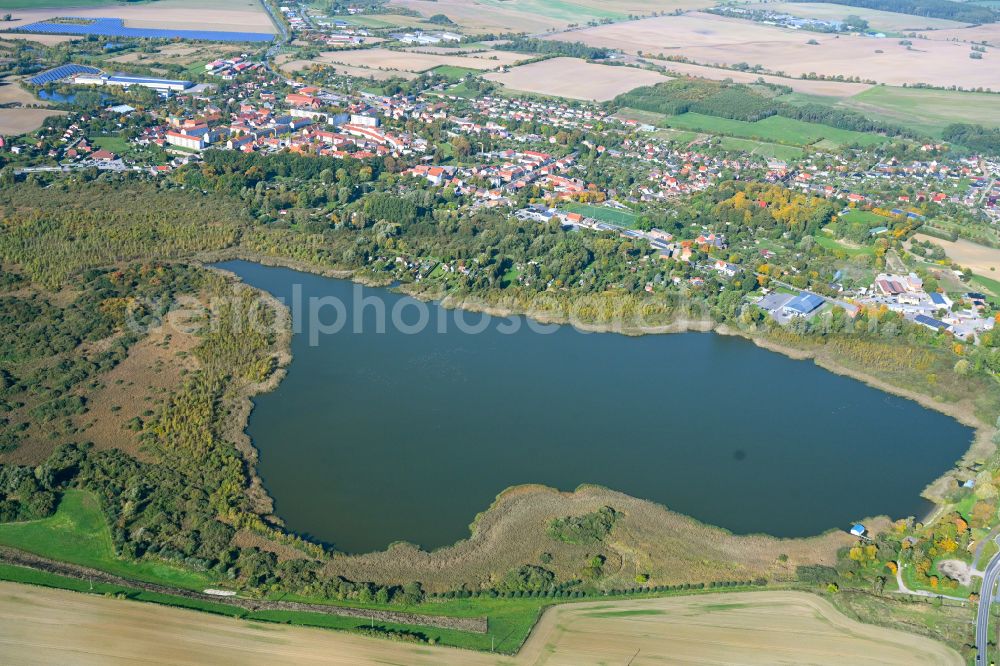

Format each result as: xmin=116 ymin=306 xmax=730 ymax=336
xmin=551 ymin=12 xmax=1000 ymax=90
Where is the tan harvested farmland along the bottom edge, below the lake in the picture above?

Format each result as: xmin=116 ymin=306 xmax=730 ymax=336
xmin=0 ymin=583 xmax=962 ymax=666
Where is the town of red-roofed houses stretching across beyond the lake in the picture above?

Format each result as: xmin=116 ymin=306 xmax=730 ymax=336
xmin=8 ymin=16 xmax=1000 ymax=348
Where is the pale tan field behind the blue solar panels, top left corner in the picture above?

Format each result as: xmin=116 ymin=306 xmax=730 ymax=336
xmin=0 ymin=0 xmax=275 ymax=33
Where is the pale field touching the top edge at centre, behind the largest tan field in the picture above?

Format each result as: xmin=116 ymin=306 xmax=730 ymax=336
xmin=380 ymin=0 xmax=715 ymax=33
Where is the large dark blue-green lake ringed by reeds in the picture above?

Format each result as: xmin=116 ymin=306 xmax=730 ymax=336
xmin=219 ymin=261 xmax=973 ymax=552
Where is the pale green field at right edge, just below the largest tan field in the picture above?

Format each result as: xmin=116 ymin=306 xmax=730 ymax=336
xmin=779 ymin=86 xmax=1000 ymax=137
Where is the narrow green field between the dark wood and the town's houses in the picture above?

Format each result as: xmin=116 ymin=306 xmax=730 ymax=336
xmin=664 ymin=113 xmax=886 ymax=146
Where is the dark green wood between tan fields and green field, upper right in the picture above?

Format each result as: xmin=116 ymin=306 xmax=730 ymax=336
xmin=614 ymin=79 xmax=910 ymax=136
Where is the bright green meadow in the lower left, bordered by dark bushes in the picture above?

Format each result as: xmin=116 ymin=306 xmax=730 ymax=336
xmin=0 ymin=490 xmax=213 ymax=590
